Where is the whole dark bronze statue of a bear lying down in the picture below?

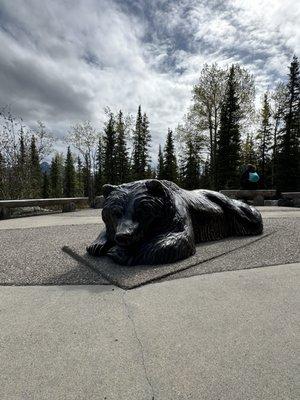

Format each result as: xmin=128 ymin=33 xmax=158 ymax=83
xmin=87 ymin=179 xmax=263 ymax=265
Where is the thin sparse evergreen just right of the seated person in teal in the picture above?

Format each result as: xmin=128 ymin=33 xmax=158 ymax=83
xmin=256 ymin=93 xmax=272 ymax=184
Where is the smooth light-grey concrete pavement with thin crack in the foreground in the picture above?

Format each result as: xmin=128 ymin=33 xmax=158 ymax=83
xmin=0 ymin=264 xmax=300 ymax=400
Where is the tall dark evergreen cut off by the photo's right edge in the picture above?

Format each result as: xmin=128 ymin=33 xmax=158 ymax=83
xmin=277 ymin=56 xmax=300 ymax=191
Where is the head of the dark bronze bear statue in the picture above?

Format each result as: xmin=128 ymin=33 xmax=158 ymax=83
xmin=102 ymin=179 xmax=173 ymax=247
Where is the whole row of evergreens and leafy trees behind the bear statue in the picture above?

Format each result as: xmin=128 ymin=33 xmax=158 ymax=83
xmin=0 ymin=56 xmax=300 ymax=199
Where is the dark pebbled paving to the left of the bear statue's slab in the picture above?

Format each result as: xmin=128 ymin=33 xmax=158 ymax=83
xmin=0 ymin=224 xmax=107 ymax=285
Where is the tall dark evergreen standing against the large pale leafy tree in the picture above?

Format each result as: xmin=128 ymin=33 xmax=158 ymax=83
xmin=217 ymin=65 xmax=241 ymax=189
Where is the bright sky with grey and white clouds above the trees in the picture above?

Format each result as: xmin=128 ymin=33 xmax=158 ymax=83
xmin=0 ymin=0 xmax=300 ymax=156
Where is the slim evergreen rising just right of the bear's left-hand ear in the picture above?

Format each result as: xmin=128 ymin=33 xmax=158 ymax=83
xmin=115 ymin=110 xmax=129 ymax=184
